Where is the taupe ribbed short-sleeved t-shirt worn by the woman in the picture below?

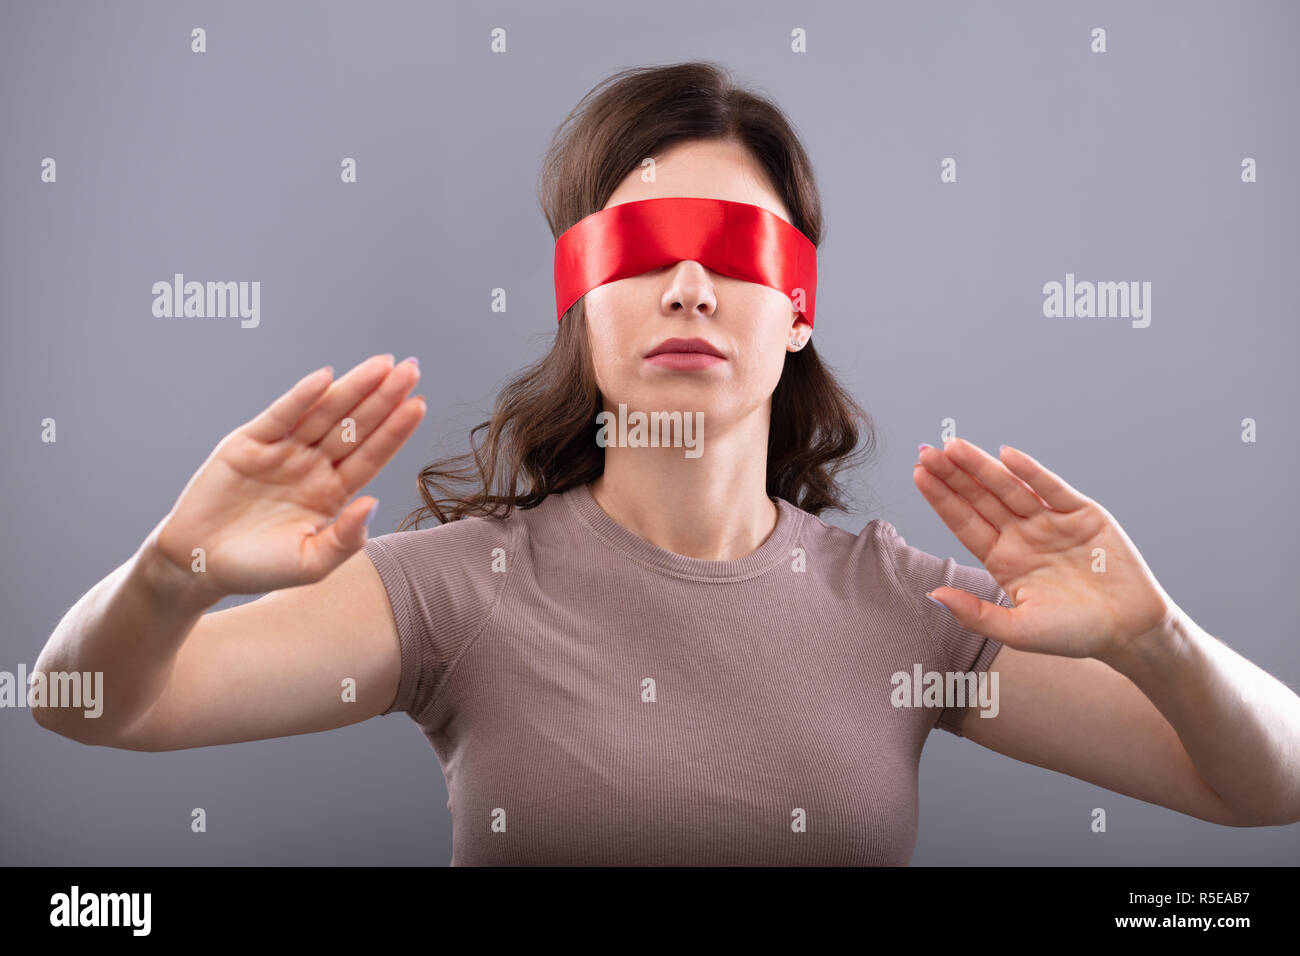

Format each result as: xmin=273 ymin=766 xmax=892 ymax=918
xmin=365 ymin=485 xmax=1011 ymax=866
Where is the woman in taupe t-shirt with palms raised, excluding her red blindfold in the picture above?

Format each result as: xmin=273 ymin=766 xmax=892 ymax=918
xmin=34 ymin=64 xmax=1300 ymax=864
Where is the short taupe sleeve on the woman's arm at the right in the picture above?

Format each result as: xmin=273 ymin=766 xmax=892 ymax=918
xmin=876 ymin=520 xmax=1014 ymax=736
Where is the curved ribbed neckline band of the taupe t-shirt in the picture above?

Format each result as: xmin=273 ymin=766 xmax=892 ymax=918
xmin=562 ymin=484 xmax=803 ymax=581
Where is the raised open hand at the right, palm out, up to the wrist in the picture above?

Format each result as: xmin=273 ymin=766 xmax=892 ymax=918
xmin=913 ymin=438 xmax=1182 ymax=659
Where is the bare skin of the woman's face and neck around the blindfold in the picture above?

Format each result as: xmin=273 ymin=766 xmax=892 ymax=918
xmin=585 ymin=140 xmax=811 ymax=561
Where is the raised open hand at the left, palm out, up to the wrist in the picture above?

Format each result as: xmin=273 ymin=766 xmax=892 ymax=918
xmin=147 ymin=355 xmax=425 ymax=604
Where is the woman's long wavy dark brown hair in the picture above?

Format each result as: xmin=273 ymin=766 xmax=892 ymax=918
xmin=399 ymin=61 xmax=875 ymax=531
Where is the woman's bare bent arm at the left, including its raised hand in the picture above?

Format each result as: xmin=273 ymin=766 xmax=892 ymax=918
xmin=33 ymin=356 xmax=425 ymax=750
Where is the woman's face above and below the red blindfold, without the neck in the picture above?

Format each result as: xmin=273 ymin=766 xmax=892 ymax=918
xmin=585 ymin=140 xmax=811 ymax=436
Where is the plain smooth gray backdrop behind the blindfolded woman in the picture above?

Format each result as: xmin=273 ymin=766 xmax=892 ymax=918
xmin=0 ymin=0 xmax=1300 ymax=865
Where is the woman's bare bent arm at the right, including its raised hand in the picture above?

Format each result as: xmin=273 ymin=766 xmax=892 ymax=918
xmin=913 ymin=438 xmax=1300 ymax=826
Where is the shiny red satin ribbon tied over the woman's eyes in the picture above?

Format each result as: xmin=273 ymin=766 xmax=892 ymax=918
xmin=555 ymin=196 xmax=816 ymax=325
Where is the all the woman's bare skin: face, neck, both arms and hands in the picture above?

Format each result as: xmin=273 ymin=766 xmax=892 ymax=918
xmin=33 ymin=142 xmax=1300 ymax=826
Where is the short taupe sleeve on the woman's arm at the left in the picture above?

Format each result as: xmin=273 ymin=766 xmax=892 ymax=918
xmin=365 ymin=518 xmax=515 ymax=721
